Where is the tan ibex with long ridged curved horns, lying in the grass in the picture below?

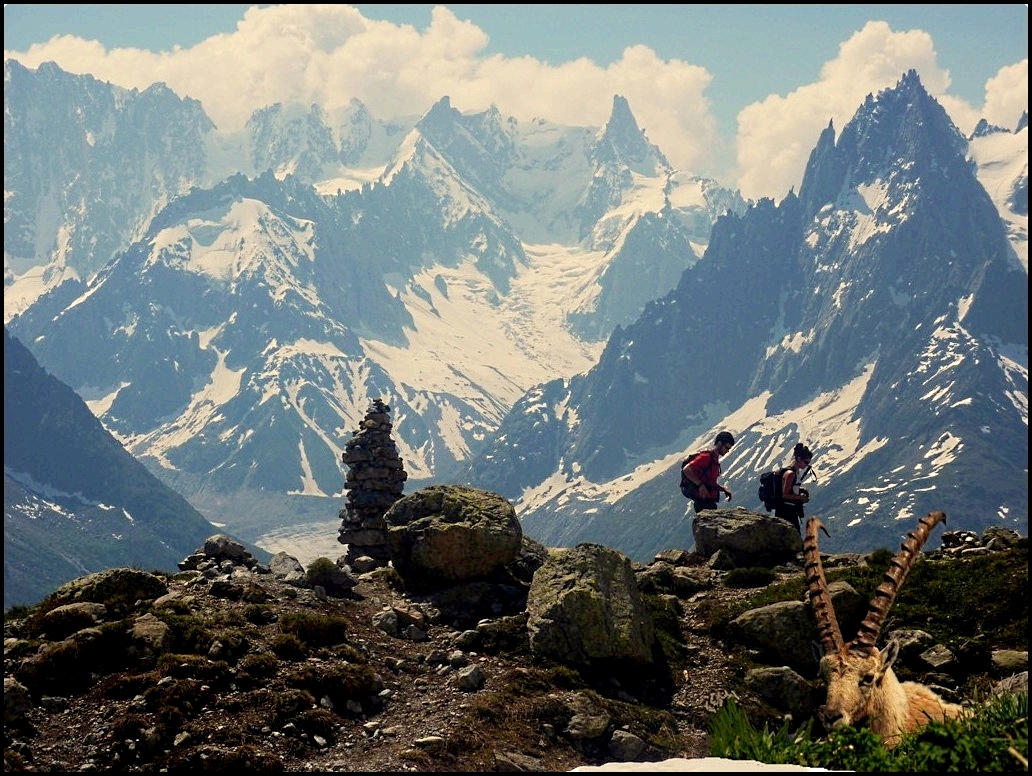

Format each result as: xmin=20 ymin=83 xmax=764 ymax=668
xmin=803 ymin=512 xmax=965 ymax=748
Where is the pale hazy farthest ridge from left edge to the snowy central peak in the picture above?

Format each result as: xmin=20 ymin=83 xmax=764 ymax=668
xmin=4 ymin=60 xmax=415 ymax=322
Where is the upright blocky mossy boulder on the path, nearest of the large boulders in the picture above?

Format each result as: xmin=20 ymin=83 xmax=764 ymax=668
xmin=526 ymin=543 xmax=655 ymax=668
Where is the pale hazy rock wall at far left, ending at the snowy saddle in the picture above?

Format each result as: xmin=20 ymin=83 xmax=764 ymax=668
xmin=3 ymin=60 xmax=214 ymax=321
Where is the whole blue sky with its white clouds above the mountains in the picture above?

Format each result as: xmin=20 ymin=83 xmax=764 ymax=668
xmin=4 ymin=3 xmax=1028 ymax=199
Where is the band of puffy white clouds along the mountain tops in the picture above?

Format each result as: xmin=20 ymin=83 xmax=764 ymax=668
xmin=4 ymin=4 xmax=1028 ymax=199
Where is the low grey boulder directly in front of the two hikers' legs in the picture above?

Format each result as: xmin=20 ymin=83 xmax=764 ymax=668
xmin=691 ymin=507 xmax=803 ymax=568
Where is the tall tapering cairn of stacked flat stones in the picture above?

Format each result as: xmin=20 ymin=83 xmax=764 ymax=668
xmin=337 ymin=398 xmax=409 ymax=570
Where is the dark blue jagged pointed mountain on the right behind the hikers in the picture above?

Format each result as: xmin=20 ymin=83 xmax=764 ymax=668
xmin=469 ymin=71 xmax=1028 ymax=559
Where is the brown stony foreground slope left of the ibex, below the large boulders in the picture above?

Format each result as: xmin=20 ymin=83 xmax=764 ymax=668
xmin=4 ymin=518 xmax=1027 ymax=772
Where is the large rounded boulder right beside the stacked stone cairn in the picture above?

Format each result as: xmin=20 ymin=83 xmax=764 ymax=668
xmin=384 ymin=485 xmax=523 ymax=586
